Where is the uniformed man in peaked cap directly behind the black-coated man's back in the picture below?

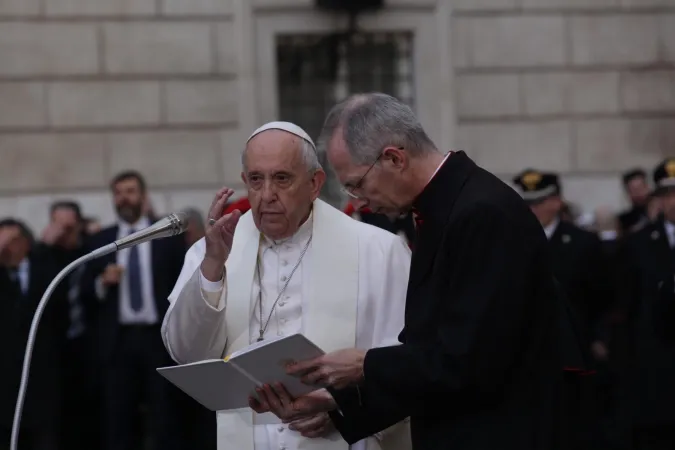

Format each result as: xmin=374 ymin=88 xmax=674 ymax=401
xmin=513 ymin=169 xmax=611 ymax=449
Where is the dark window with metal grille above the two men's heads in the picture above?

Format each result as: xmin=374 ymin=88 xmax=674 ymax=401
xmin=276 ymin=32 xmax=415 ymax=203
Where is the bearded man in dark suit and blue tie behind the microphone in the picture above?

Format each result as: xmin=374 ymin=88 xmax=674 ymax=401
xmin=85 ymin=171 xmax=186 ymax=450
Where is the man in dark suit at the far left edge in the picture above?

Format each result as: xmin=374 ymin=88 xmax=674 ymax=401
xmin=0 ymin=219 xmax=67 ymax=450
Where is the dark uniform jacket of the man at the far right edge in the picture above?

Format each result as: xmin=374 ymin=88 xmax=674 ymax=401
xmin=619 ymin=219 xmax=675 ymax=427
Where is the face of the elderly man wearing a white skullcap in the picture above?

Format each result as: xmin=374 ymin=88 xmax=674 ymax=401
xmin=242 ymin=130 xmax=326 ymax=239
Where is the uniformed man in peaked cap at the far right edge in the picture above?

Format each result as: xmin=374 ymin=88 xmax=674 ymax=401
xmin=619 ymin=158 xmax=675 ymax=450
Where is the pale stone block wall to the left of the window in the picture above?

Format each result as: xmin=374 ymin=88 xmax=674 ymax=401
xmin=0 ymin=0 xmax=241 ymax=229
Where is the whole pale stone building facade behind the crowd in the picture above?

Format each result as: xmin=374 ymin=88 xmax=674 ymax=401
xmin=0 ymin=0 xmax=675 ymax=229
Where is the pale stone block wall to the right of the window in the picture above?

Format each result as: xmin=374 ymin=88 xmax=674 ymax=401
xmin=452 ymin=0 xmax=675 ymax=209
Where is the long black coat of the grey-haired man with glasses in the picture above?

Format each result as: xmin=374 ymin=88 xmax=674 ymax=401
xmin=331 ymin=152 xmax=588 ymax=450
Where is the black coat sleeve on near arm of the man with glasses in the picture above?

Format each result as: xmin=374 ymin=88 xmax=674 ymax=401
xmin=330 ymin=205 xmax=544 ymax=437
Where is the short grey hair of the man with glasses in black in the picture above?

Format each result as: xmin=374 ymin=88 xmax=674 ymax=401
xmin=318 ymin=93 xmax=438 ymax=164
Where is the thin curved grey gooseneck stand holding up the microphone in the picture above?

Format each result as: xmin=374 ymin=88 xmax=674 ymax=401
xmin=9 ymin=242 xmax=118 ymax=450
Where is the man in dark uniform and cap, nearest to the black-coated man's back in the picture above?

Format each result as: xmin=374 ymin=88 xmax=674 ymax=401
xmin=513 ymin=169 xmax=614 ymax=449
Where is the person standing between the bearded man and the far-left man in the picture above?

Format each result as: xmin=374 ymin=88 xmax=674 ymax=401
xmin=42 ymin=201 xmax=101 ymax=450
